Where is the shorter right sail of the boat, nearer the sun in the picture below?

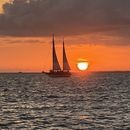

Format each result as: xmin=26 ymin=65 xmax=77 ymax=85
xmin=63 ymin=40 xmax=71 ymax=71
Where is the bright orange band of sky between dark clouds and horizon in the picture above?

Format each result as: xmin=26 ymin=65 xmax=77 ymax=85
xmin=0 ymin=36 xmax=130 ymax=72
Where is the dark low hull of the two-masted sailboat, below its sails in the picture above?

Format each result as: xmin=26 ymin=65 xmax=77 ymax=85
xmin=46 ymin=71 xmax=71 ymax=77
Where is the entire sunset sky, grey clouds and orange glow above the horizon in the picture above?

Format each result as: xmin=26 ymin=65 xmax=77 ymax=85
xmin=0 ymin=0 xmax=130 ymax=72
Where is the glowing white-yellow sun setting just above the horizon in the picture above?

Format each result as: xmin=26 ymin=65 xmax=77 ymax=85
xmin=77 ymin=60 xmax=89 ymax=71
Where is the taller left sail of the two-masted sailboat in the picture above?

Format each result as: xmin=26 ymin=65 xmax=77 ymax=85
xmin=52 ymin=35 xmax=61 ymax=71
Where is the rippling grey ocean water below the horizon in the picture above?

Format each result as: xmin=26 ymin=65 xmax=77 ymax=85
xmin=0 ymin=72 xmax=130 ymax=130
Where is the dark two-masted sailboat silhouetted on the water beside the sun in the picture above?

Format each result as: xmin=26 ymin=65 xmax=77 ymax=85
xmin=46 ymin=35 xmax=71 ymax=77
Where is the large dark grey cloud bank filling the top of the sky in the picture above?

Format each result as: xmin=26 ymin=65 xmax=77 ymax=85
xmin=0 ymin=0 xmax=130 ymax=45
